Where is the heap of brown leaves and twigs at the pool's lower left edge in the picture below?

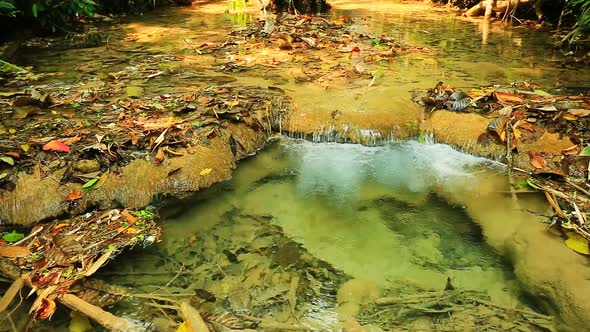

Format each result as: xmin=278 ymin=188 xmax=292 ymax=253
xmin=0 ymin=209 xmax=160 ymax=319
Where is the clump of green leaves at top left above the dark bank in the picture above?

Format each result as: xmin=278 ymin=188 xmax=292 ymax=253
xmin=31 ymin=0 xmax=97 ymax=32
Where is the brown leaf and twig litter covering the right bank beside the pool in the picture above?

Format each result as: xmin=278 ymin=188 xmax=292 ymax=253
xmin=413 ymin=82 xmax=590 ymax=255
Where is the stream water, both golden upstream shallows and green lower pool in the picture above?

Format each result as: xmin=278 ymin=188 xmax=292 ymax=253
xmin=4 ymin=0 xmax=590 ymax=330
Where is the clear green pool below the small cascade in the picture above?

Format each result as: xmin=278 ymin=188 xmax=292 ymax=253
xmin=100 ymin=138 xmax=531 ymax=330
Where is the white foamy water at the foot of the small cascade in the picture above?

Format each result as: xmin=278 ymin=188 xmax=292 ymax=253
xmin=285 ymin=139 xmax=497 ymax=195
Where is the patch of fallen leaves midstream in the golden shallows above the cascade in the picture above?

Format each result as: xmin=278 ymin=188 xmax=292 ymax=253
xmin=197 ymin=14 xmax=435 ymax=89
